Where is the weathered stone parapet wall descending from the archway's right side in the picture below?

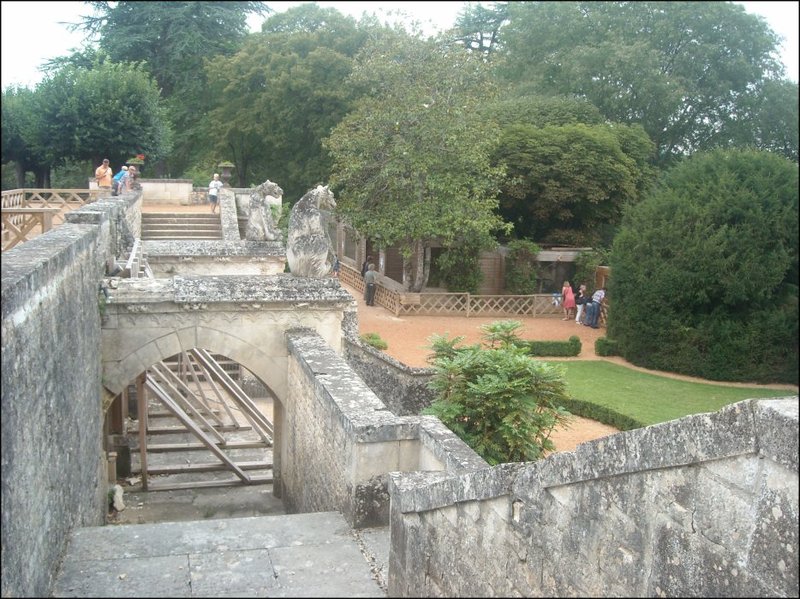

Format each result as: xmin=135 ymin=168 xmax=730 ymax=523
xmin=276 ymin=329 xmax=486 ymax=527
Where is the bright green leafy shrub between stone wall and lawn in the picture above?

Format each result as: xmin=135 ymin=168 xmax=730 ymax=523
xmin=424 ymin=323 xmax=568 ymax=465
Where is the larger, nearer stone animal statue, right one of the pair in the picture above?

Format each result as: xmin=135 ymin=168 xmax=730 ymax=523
xmin=286 ymin=185 xmax=336 ymax=278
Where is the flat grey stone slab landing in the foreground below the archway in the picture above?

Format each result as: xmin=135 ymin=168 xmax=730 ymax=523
xmin=52 ymin=512 xmax=388 ymax=597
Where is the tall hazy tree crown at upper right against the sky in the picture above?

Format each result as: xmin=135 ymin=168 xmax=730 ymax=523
xmin=498 ymin=2 xmax=797 ymax=163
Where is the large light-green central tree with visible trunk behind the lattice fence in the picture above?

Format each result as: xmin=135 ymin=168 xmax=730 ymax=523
xmin=326 ymin=33 xmax=510 ymax=291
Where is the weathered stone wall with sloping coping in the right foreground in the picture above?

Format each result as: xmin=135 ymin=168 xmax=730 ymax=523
xmin=389 ymin=397 xmax=798 ymax=597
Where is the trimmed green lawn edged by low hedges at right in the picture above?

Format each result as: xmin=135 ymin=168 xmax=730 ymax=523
xmin=547 ymin=360 xmax=797 ymax=428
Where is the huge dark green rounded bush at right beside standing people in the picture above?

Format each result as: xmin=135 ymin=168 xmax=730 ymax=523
xmin=608 ymin=150 xmax=798 ymax=383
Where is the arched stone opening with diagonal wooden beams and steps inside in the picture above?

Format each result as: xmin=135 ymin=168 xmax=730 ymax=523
xmin=107 ymin=348 xmax=276 ymax=491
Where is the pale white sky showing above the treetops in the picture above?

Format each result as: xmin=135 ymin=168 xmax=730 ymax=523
xmin=0 ymin=0 xmax=800 ymax=89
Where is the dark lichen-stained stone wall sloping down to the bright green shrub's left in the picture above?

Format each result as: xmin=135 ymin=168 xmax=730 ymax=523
xmin=344 ymin=338 xmax=433 ymax=416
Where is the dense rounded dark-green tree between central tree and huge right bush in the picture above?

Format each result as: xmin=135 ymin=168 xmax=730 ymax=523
xmin=494 ymin=123 xmax=652 ymax=245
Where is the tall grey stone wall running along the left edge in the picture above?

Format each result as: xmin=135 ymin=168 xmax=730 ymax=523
xmin=2 ymin=197 xmax=138 ymax=597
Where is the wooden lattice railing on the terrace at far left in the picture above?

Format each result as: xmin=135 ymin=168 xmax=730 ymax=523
xmin=0 ymin=189 xmax=106 ymax=250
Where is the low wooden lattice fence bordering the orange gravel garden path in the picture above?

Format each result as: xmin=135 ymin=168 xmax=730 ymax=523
xmin=339 ymin=264 xmax=606 ymax=324
